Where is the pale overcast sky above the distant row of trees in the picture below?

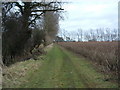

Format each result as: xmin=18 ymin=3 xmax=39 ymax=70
xmin=60 ymin=0 xmax=119 ymax=31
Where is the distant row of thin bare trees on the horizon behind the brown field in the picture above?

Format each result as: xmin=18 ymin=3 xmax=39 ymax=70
xmin=59 ymin=28 xmax=119 ymax=41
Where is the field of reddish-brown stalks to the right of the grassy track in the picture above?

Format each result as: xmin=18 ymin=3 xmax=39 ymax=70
xmin=58 ymin=42 xmax=118 ymax=79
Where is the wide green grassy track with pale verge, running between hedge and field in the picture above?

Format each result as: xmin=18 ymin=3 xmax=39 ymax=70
xmin=4 ymin=46 xmax=117 ymax=88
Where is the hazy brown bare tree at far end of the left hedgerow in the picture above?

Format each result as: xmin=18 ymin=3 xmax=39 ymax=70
xmin=44 ymin=12 xmax=59 ymax=45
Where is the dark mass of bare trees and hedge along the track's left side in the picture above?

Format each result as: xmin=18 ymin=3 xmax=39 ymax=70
xmin=2 ymin=1 xmax=63 ymax=65
